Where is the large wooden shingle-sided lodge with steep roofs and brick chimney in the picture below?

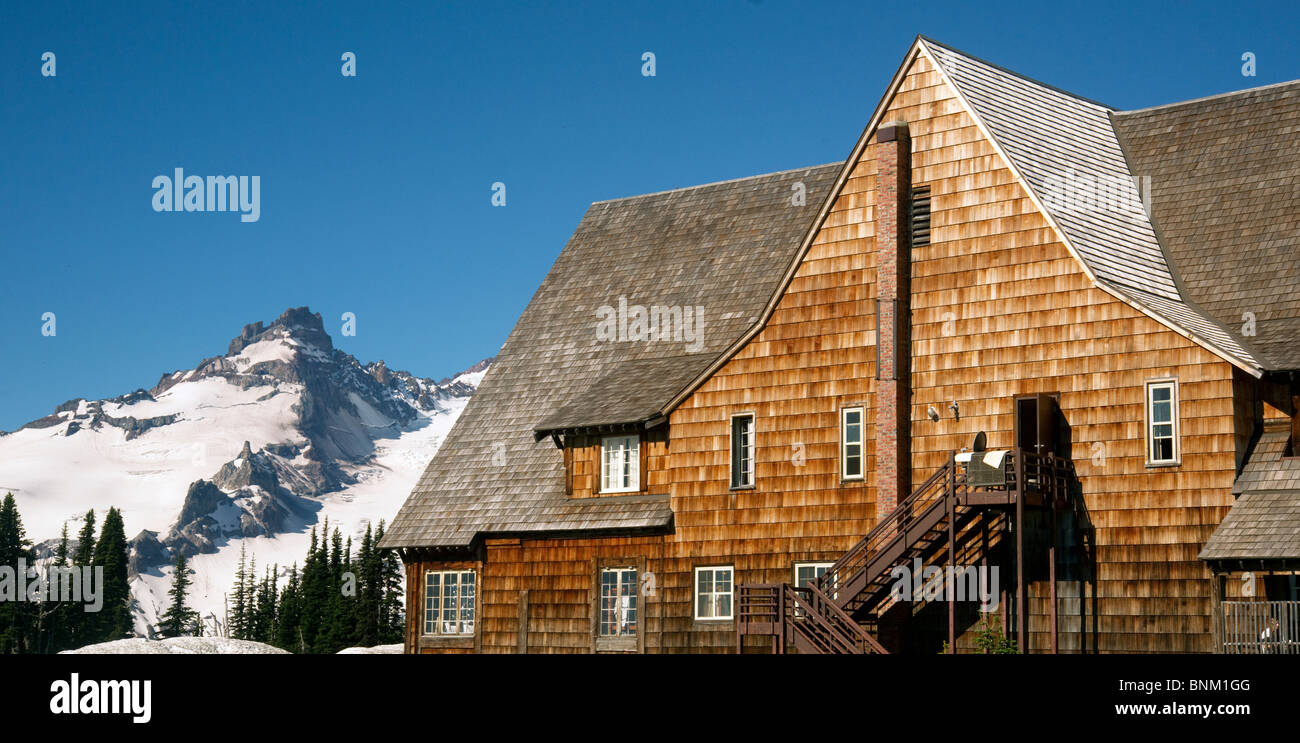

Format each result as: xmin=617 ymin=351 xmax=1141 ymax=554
xmin=382 ymin=38 xmax=1300 ymax=653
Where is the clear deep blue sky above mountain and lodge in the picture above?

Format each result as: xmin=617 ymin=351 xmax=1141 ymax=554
xmin=0 ymin=0 xmax=1300 ymax=430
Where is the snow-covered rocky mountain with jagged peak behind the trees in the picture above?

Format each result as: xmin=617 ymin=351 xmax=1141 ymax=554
xmin=0 ymin=308 xmax=491 ymax=634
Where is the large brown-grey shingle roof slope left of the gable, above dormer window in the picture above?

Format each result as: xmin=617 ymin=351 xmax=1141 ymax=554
xmin=384 ymin=164 xmax=842 ymax=547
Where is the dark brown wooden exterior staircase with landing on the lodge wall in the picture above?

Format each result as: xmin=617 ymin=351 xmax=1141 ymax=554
xmin=736 ymin=449 xmax=1074 ymax=655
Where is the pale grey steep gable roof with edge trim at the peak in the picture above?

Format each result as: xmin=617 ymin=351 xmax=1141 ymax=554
xmin=663 ymin=36 xmax=1262 ymax=414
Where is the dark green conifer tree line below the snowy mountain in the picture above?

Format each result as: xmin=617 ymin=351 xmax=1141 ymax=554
xmin=0 ymin=494 xmax=404 ymax=655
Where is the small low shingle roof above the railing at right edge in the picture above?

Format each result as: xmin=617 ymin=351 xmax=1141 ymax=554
xmin=1200 ymin=427 xmax=1300 ymax=560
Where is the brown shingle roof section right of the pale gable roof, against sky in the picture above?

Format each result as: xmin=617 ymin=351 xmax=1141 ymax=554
xmin=1114 ymin=81 xmax=1300 ymax=369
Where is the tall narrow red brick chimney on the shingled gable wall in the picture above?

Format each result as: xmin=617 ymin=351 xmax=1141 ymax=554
xmin=876 ymin=121 xmax=911 ymax=520
